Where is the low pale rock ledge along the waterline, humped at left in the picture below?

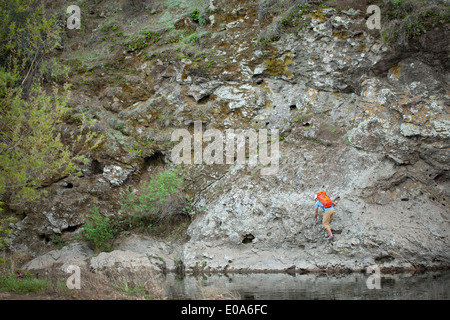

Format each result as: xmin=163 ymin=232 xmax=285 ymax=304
xmin=23 ymin=232 xmax=450 ymax=275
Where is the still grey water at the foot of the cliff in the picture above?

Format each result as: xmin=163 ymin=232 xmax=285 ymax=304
xmin=163 ymin=272 xmax=450 ymax=300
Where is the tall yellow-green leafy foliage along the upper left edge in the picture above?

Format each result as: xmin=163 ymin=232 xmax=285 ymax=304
xmin=0 ymin=0 xmax=100 ymax=211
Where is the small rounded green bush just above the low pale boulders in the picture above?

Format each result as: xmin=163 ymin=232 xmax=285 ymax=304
xmin=80 ymin=206 xmax=118 ymax=252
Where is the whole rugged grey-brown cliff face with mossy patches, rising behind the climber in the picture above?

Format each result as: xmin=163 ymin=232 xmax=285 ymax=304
xmin=8 ymin=1 xmax=450 ymax=271
